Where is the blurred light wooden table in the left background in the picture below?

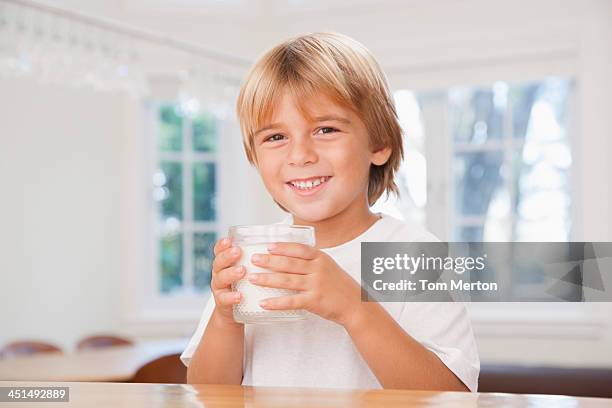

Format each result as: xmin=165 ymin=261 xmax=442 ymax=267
xmin=0 ymin=340 xmax=187 ymax=381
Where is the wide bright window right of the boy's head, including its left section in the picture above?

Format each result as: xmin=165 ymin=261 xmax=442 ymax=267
xmin=376 ymin=77 xmax=573 ymax=300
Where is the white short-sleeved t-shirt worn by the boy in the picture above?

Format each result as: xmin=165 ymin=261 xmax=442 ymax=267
xmin=181 ymin=213 xmax=480 ymax=391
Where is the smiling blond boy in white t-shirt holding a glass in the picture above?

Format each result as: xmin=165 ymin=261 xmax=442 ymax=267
xmin=181 ymin=33 xmax=480 ymax=391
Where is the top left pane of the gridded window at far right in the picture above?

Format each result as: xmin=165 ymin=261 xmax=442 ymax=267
xmin=449 ymin=82 xmax=508 ymax=144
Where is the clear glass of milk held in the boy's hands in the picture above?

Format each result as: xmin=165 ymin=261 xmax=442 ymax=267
xmin=229 ymin=224 xmax=315 ymax=323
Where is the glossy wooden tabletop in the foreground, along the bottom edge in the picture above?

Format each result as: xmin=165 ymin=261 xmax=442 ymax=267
xmin=0 ymin=381 xmax=612 ymax=408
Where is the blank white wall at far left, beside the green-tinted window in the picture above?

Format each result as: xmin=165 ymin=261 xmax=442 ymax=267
xmin=0 ymin=79 xmax=123 ymax=347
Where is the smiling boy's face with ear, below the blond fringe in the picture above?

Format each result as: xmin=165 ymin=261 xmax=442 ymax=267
xmin=254 ymin=92 xmax=391 ymax=222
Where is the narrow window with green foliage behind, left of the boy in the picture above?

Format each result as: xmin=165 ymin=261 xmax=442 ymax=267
xmin=150 ymin=102 xmax=218 ymax=295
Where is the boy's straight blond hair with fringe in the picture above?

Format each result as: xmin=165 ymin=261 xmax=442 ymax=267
xmin=236 ymin=32 xmax=404 ymax=208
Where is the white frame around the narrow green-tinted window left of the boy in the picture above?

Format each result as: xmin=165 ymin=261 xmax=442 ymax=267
xmin=118 ymin=95 xmax=226 ymax=337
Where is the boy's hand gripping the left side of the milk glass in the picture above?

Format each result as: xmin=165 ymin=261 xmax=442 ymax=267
xmin=210 ymin=237 xmax=246 ymax=324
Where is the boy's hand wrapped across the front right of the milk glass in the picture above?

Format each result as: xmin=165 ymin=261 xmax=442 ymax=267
xmin=248 ymin=242 xmax=361 ymax=325
